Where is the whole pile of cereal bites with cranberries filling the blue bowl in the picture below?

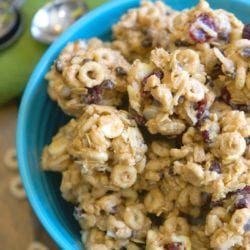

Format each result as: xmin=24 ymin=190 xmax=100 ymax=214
xmin=42 ymin=0 xmax=250 ymax=250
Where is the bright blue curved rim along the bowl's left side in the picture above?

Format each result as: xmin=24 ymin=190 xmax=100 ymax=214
xmin=16 ymin=0 xmax=138 ymax=249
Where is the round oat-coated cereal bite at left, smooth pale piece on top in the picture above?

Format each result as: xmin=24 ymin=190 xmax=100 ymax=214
xmin=42 ymin=105 xmax=147 ymax=188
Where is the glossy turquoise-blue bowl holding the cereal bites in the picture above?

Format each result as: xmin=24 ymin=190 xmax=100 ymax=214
xmin=17 ymin=0 xmax=250 ymax=250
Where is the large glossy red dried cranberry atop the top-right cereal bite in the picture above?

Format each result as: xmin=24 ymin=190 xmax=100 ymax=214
xmin=189 ymin=13 xmax=217 ymax=43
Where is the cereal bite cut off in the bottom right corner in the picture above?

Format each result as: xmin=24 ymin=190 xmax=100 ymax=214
xmin=205 ymin=186 xmax=250 ymax=249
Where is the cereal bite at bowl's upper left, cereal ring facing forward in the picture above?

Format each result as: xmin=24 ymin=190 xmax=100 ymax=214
xmin=46 ymin=39 xmax=129 ymax=117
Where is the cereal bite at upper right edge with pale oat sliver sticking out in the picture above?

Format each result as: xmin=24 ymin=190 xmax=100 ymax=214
xmin=215 ymin=39 xmax=250 ymax=108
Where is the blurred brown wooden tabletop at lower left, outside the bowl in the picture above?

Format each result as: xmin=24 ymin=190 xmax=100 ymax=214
xmin=0 ymin=101 xmax=59 ymax=250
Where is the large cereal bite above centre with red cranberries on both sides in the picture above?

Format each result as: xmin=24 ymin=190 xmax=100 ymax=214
xmin=128 ymin=49 xmax=214 ymax=136
